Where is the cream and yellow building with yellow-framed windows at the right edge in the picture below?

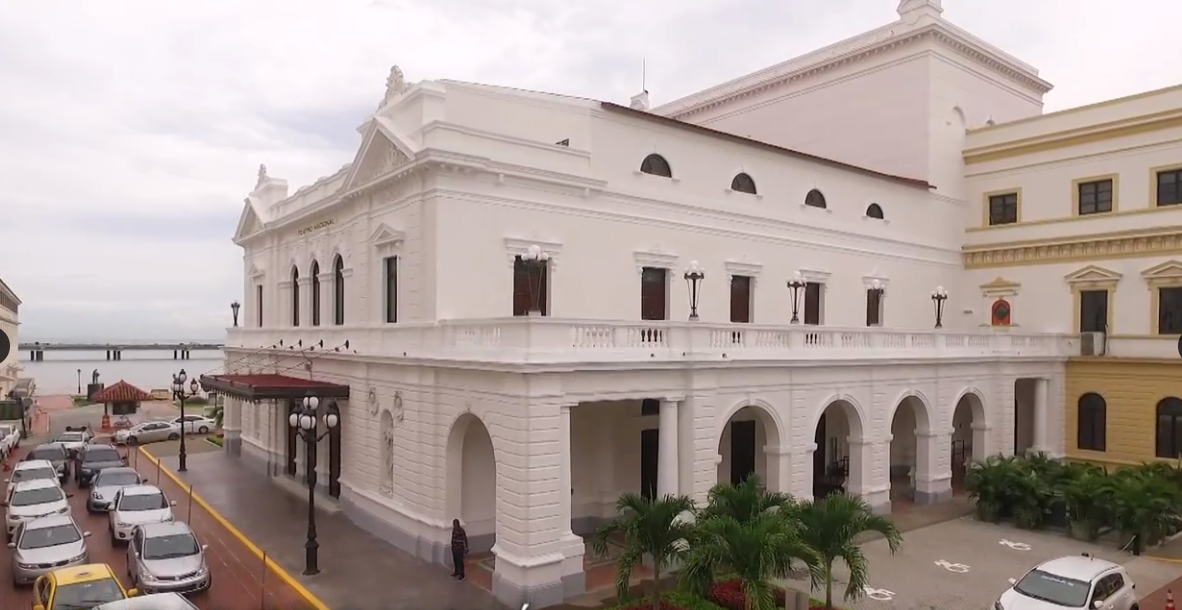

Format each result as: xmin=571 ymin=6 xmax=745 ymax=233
xmin=963 ymin=86 xmax=1182 ymax=466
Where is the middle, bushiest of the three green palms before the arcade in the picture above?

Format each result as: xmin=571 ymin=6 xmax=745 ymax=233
xmin=681 ymin=511 xmax=819 ymax=610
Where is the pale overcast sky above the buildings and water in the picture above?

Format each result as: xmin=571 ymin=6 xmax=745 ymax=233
xmin=0 ymin=0 xmax=1182 ymax=340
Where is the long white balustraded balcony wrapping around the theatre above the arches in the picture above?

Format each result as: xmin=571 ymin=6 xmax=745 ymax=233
xmin=217 ymin=317 xmax=1079 ymax=364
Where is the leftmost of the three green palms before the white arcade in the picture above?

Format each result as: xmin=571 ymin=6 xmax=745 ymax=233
xmin=591 ymin=492 xmax=694 ymax=610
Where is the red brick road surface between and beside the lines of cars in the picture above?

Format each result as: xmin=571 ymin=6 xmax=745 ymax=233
xmin=0 ymin=442 xmax=316 ymax=610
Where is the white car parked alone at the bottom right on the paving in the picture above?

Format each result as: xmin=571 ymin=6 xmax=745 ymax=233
xmin=993 ymin=553 xmax=1137 ymax=610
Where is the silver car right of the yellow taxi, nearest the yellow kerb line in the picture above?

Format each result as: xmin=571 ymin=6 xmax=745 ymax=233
xmin=128 ymin=521 xmax=210 ymax=593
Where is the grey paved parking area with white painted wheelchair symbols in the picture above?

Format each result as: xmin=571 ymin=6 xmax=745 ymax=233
xmin=786 ymin=517 xmax=1182 ymax=610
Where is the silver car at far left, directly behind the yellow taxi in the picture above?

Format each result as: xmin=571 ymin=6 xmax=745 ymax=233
xmin=8 ymin=514 xmax=90 ymax=585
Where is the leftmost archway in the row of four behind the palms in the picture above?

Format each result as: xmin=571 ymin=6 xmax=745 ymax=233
xmin=717 ymin=404 xmax=786 ymax=492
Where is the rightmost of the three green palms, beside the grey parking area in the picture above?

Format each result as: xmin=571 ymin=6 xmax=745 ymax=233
xmin=797 ymin=494 xmax=903 ymax=610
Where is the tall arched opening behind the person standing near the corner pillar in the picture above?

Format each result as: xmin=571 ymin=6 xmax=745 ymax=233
xmin=444 ymin=413 xmax=496 ymax=553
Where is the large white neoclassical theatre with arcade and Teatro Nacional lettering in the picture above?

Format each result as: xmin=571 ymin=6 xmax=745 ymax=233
xmin=202 ymin=0 xmax=1111 ymax=606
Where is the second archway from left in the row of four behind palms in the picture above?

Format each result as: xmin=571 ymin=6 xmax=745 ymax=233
xmin=813 ymin=400 xmax=862 ymax=499
